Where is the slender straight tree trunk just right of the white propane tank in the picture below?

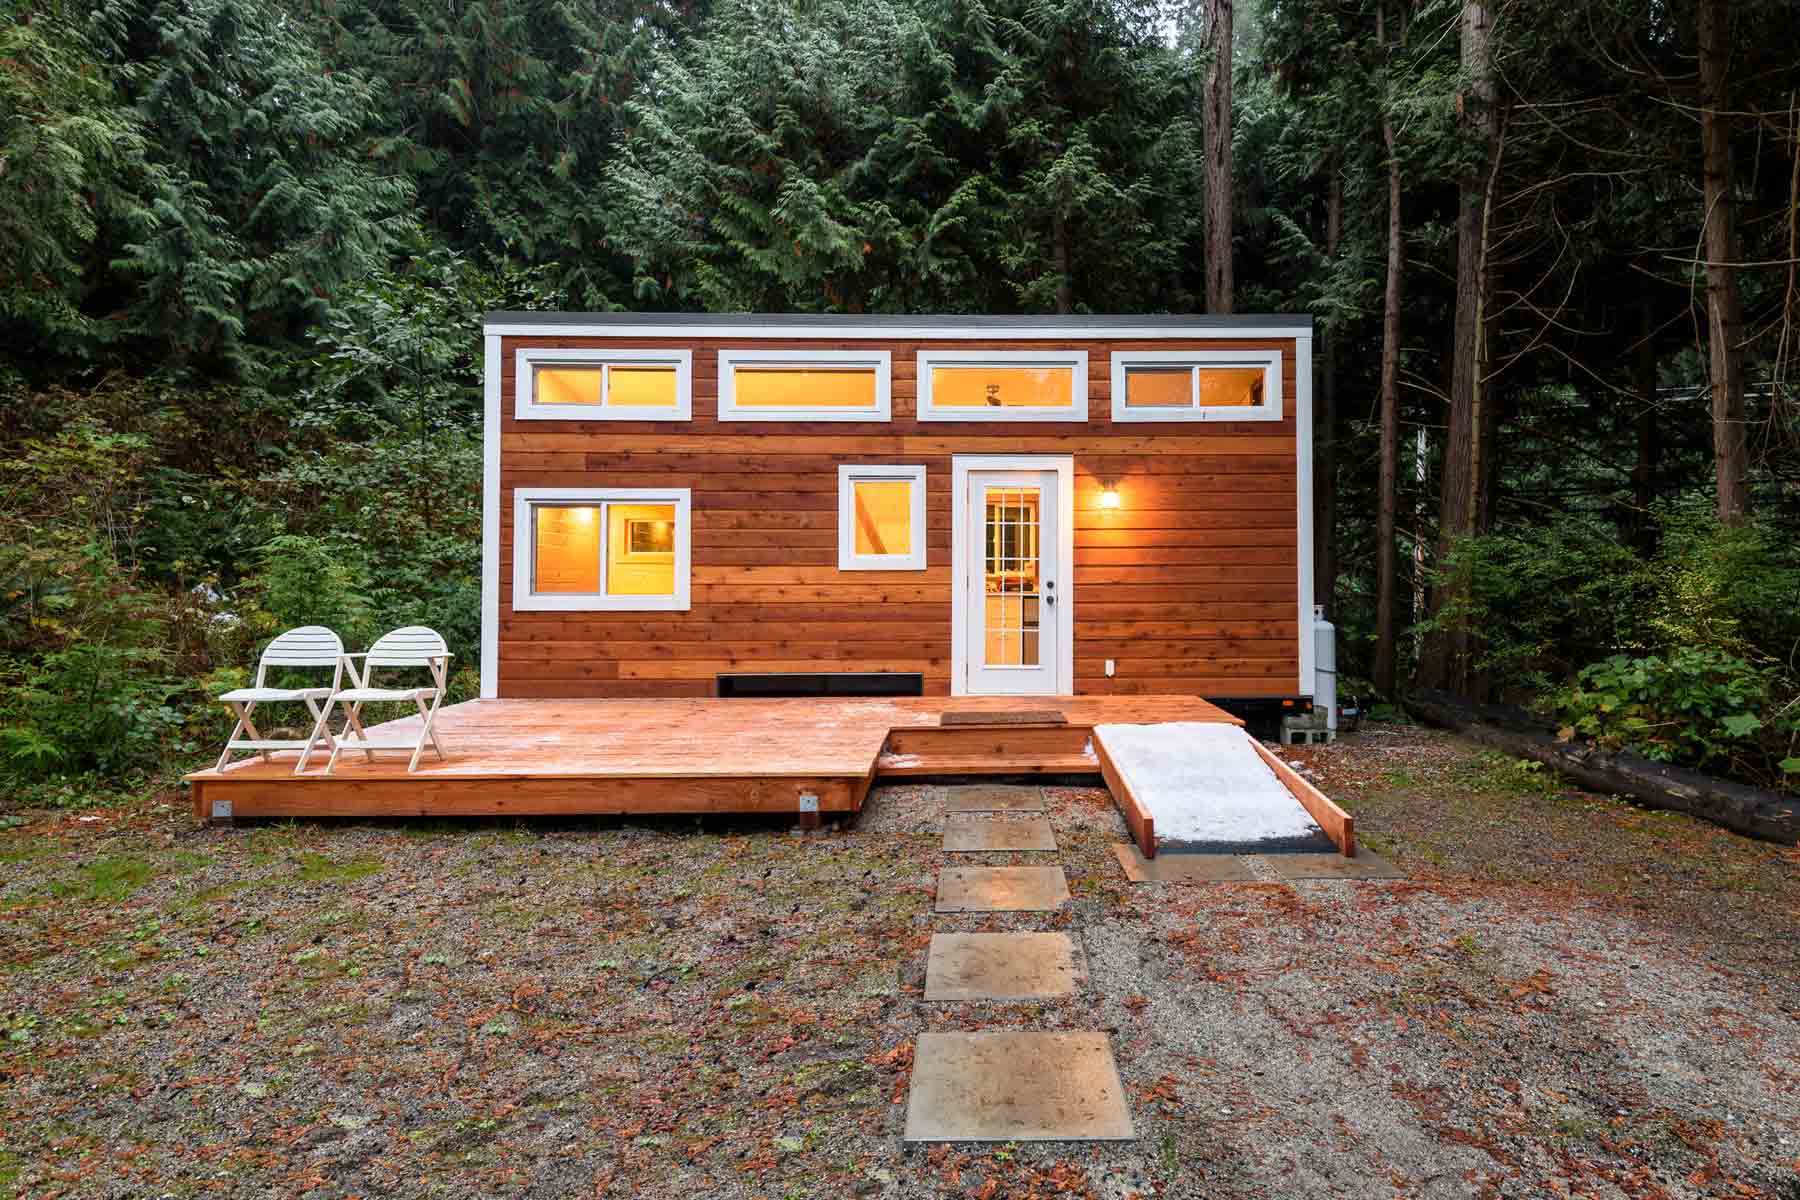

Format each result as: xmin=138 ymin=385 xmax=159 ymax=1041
xmin=1375 ymin=0 xmax=1404 ymax=698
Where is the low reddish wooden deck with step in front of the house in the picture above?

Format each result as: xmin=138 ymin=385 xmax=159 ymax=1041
xmin=187 ymin=696 xmax=1238 ymax=822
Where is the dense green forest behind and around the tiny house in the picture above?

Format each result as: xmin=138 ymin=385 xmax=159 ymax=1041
xmin=0 ymin=0 xmax=1800 ymax=804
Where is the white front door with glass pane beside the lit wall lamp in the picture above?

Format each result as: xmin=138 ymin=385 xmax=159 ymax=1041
xmin=954 ymin=459 xmax=1073 ymax=696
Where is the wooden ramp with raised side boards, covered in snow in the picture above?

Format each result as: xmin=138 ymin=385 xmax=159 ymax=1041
xmin=1094 ymin=721 xmax=1355 ymax=858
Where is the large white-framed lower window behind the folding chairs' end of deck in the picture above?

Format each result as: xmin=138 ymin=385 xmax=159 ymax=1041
xmin=513 ymin=488 xmax=693 ymax=612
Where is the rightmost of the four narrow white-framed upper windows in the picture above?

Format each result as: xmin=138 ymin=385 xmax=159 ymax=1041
xmin=1112 ymin=351 xmax=1282 ymax=421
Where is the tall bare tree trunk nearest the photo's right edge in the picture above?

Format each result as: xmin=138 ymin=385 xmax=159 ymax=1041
xmin=1699 ymin=0 xmax=1750 ymax=525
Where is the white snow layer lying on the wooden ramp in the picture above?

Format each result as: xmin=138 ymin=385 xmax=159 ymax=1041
xmin=1094 ymin=721 xmax=1337 ymax=855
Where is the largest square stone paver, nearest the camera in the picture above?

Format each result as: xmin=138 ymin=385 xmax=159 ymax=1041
xmin=905 ymin=1033 xmax=1136 ymax=1142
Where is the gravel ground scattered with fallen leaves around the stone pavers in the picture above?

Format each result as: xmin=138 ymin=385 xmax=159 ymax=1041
xmin=0 ymin=727 xmax=1800 ymax=1200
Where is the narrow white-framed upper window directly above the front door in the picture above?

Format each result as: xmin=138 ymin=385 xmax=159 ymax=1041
xmin=918 ymin=349 xmax=1087 ymax=421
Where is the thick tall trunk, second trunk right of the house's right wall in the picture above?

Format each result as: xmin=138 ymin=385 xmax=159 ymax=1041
xmin=1418 ymin=0 xmax=1498 ymax=693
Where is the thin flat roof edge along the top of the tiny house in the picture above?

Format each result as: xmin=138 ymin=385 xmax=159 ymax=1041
xmin=482 ymin=311 xmax=1312 ymax=333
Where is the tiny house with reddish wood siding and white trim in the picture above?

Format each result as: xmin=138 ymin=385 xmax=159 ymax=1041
xmin=481 ymin=313 xmax=1314 ymax=702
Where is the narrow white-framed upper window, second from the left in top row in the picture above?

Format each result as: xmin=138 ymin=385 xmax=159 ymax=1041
xmin=718 ymin=351 xmax=893 ymax=421
